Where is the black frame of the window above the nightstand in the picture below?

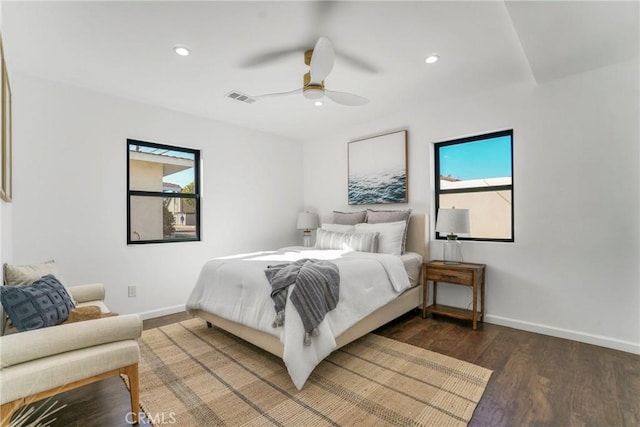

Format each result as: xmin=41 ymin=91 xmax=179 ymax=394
xmin=433 ymin=129 xmax=515 ymax=242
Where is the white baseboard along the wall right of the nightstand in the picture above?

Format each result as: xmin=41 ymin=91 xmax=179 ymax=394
xmin=485 ymin=314 xmax=640 ymax=354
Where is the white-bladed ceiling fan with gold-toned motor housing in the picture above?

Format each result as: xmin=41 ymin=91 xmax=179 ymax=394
xmin=253 ymin=37 xmax=369 ymax=106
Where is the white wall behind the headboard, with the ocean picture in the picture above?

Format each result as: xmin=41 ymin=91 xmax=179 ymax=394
xmin=304 ymin=61 xmax=640 ymax=353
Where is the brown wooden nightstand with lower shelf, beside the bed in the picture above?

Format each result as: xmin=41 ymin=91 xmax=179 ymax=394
xmin=422 ymin=261 xmax=486 ymax=329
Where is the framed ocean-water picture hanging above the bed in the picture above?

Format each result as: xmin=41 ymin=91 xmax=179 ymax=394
xmin=347 ymin=130 xmax=408 ymax=205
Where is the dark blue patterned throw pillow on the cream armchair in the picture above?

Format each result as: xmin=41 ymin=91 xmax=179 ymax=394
xmin=0 ymin=274 xmax=75 ymax=332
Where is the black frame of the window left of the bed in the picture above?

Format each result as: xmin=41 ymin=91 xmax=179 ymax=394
xmin=126 ymin=138 xmax=201 ymax=245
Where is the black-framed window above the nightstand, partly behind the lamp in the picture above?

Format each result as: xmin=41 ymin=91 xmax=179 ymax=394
xmin=434 ymin=130 xmax=514 ymax=242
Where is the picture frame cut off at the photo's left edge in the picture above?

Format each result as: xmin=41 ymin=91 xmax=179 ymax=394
xmin=0 ymin=35 xmax=13 ymax=202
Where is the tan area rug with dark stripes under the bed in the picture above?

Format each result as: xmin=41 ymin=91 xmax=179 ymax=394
xmin=140 ymin=319 xmax=491 ymax=427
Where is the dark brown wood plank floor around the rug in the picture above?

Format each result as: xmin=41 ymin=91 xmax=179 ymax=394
xmin=13 ymin=313 xmax=640 ymax=427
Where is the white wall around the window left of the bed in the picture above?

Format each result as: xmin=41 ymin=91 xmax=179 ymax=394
xmin=11 ymin=75 xmax=303 ymax=315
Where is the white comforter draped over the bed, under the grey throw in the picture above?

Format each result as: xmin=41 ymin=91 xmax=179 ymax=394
xmin=187 ymin=247 xmax=410 ymax=390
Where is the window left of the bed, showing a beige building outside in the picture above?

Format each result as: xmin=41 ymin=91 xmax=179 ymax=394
xmin=127 ymin=139 xmax=200 ymax=244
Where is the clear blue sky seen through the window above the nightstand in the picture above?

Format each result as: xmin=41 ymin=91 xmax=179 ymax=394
xmin=440 ymin=135 xmax=511 ymax=181
